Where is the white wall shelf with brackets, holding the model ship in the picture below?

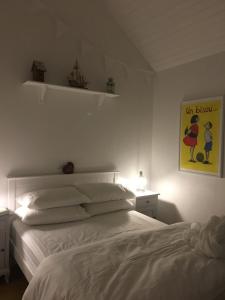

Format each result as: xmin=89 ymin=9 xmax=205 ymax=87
xmin=23 ymin=81 xmax=119 ymax=102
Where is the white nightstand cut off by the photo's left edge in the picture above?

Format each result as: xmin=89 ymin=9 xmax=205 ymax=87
xmin=0 ymin=209 xmax=9 ymax=282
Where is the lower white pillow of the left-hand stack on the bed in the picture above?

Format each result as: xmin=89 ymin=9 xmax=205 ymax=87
xmin=15 ymin=205 xmax=89 ymax=225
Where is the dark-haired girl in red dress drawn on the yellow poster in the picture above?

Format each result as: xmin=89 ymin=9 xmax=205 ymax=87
xmin=183 ymin=115 xmax=199 ymax=162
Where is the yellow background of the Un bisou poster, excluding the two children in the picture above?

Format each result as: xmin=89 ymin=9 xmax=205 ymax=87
xmin=180 ymin=97 xmax=222 ymax=175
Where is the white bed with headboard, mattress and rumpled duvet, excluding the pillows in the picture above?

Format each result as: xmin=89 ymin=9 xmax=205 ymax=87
xmin=9 ymin=172 xmax=225 ymax=300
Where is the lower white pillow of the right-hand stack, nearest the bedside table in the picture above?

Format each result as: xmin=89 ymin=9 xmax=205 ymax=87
xmin=82 ymin=200 xmax=134 ymax=216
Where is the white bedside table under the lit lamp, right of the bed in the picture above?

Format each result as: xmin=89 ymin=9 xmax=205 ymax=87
xmin=135 ymin=191 xmax=159 ymax=218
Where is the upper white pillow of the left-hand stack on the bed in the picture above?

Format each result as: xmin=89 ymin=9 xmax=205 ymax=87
xmin=17 ymin=186 xmax=90 ymax=209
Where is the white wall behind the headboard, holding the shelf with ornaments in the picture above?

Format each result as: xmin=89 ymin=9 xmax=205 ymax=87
xmin=0 ymin=0 xmax=152 ymax=205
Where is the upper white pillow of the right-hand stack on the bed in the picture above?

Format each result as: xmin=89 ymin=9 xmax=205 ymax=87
xmin=76 ymin=183 xmax=135 ymax=203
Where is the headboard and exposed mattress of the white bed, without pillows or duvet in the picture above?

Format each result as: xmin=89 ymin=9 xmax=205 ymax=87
xmin=8 ymin=171 xmax=165 ymax=281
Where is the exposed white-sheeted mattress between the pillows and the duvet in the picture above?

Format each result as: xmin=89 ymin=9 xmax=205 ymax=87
xmin=11 ymin=210 xmax=165 ymax=275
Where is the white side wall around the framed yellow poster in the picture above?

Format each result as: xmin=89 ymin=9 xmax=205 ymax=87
xmin=151 ymin=53 xmax=225 ymax=223
